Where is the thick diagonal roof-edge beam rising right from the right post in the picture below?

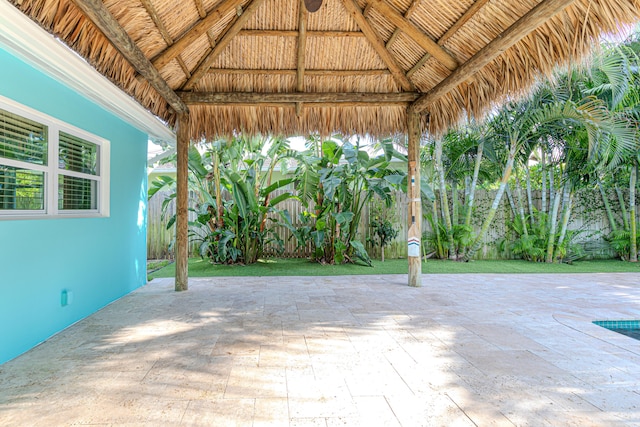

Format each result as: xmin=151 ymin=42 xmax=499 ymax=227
xmin=411 ymin=0 xmax=575 ymax=112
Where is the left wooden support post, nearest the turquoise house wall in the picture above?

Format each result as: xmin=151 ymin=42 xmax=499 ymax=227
xmin=175 ymin=113 xmax=190 ymax=291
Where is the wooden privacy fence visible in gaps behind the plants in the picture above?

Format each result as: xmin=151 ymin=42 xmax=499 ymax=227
xmin=147 ymin=190 xmax=617 ymax=259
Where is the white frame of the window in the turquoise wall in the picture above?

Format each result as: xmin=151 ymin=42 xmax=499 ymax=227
xmin=0 ymin=95 xmax=111 ymax=221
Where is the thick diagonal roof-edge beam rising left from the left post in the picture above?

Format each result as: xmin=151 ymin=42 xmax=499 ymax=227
xmin=74 ymin=0 xmax=189 ymax=113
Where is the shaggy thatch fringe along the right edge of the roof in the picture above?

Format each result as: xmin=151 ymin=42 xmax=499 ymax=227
xmin=421 ymin=0 xmax=640 ymax=136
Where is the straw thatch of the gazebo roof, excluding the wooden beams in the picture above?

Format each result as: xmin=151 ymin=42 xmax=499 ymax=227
xmin=10 ymin=0 xmax=640 ymax=138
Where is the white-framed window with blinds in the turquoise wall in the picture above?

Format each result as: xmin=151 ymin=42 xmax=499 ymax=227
xmin=0 ymin=97 xmax=109 ymax=219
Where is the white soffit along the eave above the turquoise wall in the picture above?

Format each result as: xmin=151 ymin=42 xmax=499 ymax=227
xmin=0 ymin=0 xmax=176 ymax=145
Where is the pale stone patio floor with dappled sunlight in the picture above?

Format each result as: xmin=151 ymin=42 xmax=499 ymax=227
xmin=0 ymin=274 xmax=640 ymax=426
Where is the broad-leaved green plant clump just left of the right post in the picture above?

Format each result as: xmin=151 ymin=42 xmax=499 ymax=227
xmin=290 ymin=136 xmax=406 ymax=264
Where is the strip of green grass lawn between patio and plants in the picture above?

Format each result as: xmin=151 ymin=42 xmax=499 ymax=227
xmin=149 ymin=258 xmax=640 ymax=280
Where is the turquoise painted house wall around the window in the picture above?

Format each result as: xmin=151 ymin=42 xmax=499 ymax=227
xmin=0 ymin=47 xmax=147 ymax=364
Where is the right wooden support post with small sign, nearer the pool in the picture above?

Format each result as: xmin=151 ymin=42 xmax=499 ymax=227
xmin=407 ymin=108 xmax=422 ymax=287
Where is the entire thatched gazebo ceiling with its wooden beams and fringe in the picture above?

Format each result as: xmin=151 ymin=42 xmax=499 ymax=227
xmin=10 ymin=0 xmax=640 ymax=139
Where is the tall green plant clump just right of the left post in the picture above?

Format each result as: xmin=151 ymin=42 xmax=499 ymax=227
xmin=149 ymin=137 xmax=297 ymax=263
